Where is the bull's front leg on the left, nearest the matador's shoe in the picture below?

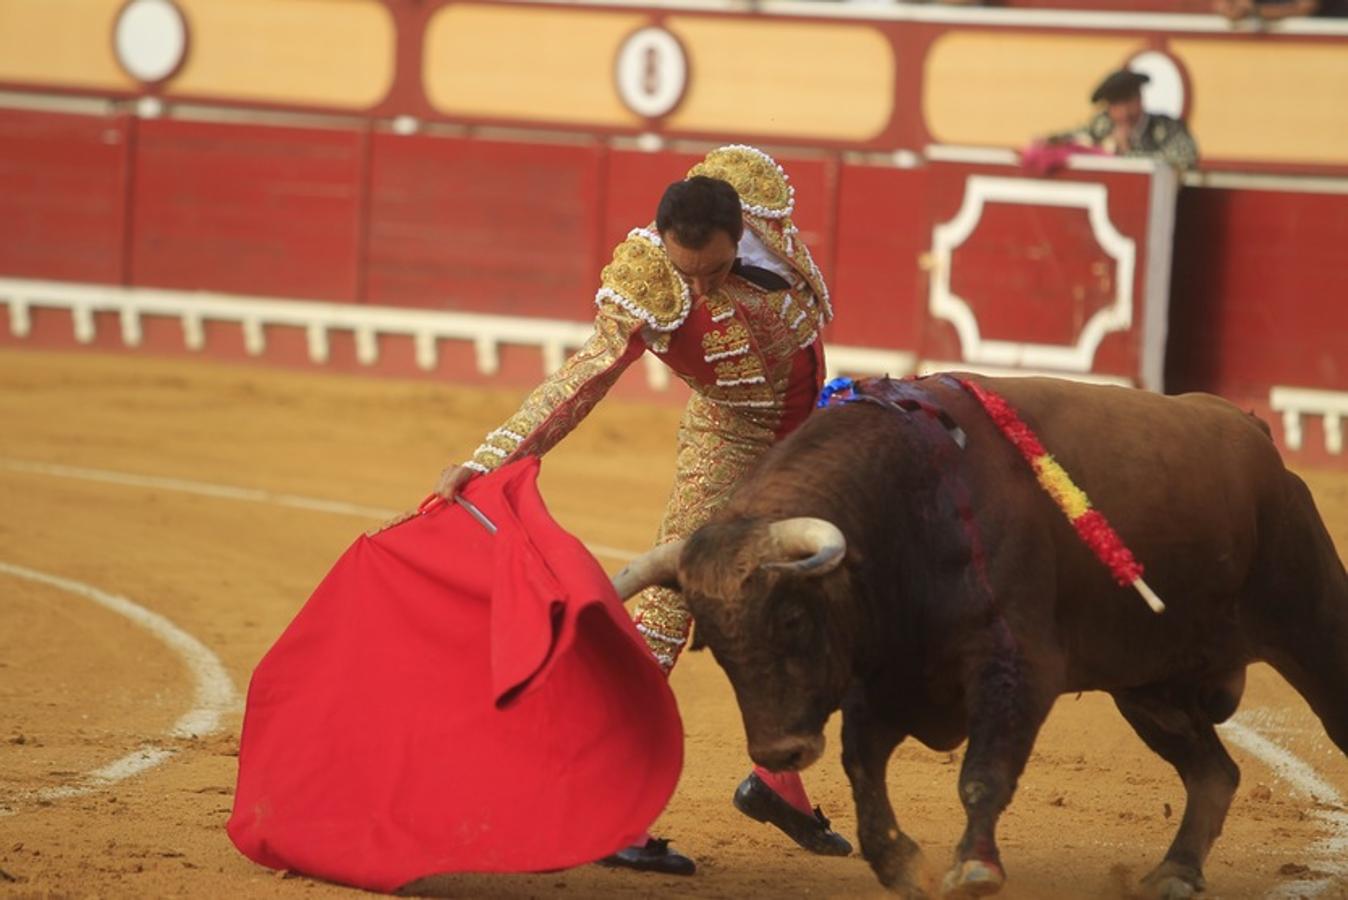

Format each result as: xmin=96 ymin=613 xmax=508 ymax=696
xmin=843 ymin=691 xmax=929 ymax=900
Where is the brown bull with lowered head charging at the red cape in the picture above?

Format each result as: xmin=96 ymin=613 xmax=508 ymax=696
xmin=615 ymin=376 xmax=1348 ymax=899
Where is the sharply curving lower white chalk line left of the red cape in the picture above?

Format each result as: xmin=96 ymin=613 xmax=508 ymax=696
xmin=0 ymin=562 xmax=239 ymax=816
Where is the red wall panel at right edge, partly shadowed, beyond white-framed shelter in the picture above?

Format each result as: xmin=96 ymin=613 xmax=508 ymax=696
xmin=1167 ymin=189 xmax=1348 ymax=395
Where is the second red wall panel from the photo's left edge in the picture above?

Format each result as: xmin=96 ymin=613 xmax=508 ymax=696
xmin=131 ymin=120 xmax=365 ymax=300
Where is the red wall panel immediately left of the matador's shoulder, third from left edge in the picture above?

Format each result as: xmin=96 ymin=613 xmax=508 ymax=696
xmin=365 ymin=135 xmax=604 ymax=319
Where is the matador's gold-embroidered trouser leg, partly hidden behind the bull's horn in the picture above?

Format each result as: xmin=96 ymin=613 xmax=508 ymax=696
xmin=634 ymin=395 xmax=774 ymax=672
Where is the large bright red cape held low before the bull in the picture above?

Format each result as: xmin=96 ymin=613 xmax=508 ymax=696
xmin=226 ymin=459 xmax=683 ymax=891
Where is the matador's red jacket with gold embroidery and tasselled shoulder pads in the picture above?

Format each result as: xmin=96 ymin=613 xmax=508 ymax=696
xmin=464 ymin=146 xmax=833 ymax=472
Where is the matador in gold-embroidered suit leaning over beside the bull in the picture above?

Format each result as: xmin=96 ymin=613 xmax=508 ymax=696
xmin=437 ymin=146 xmax=851 ymax=873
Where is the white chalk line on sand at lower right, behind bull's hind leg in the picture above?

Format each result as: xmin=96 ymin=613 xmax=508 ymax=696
xmin=1219 ymin=713 xmax=1348 ymax=899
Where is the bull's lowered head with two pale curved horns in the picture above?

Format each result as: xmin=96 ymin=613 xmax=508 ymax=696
xmin=613 ymin=519 xmax=849 ymax=769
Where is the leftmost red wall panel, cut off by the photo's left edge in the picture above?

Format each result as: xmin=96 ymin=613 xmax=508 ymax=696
xmin=0 ymin=109 xmax=133 ymax=284
